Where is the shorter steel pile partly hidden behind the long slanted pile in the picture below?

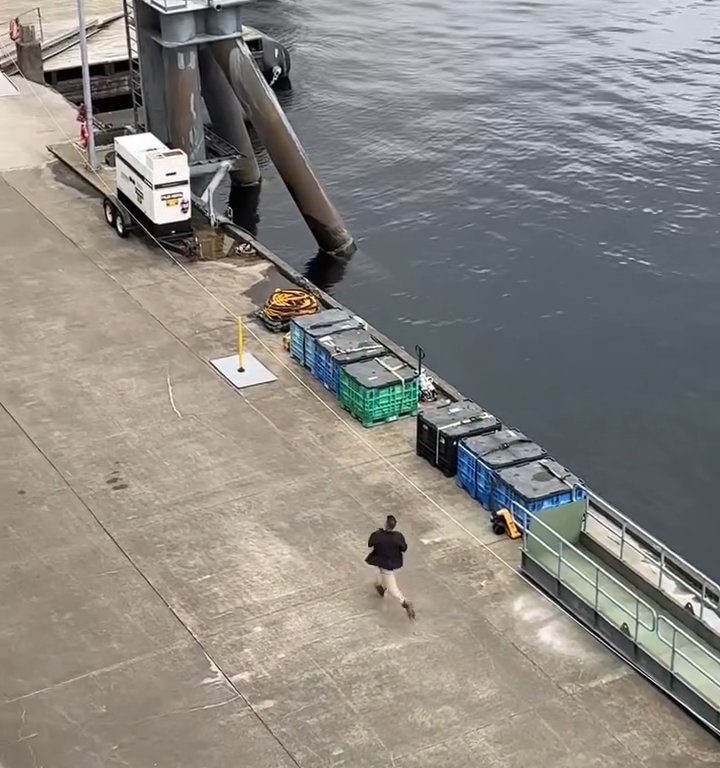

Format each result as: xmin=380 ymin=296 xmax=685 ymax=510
xmin=200 ymin=47 xmax=260 ymax=185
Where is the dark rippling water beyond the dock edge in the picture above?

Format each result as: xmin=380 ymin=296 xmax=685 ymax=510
xmin=239 ymin=0 xmax=720 ymax=577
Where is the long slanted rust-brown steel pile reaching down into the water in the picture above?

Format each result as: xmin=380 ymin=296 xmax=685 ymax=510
xmin=210 ymin=40 xmax=356 ymax=255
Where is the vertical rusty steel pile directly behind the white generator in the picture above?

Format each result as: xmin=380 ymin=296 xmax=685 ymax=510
xmin=160 ymin=12 xmax=205 ymax=163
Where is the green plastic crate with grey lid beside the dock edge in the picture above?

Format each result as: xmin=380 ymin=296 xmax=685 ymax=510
xmin=338 ymin=355 xmax=420 ymax=427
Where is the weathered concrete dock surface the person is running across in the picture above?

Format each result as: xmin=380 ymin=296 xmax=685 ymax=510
xmin=0 ymin=79 xmax=720 ymax=768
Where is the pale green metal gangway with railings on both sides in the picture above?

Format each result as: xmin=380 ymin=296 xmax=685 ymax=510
xmin=512 ymin=494 xmax=720 ymax=735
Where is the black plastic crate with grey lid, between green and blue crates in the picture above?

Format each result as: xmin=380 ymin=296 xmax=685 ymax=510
xmin=416 ymin=400 xmax=502 ymax=477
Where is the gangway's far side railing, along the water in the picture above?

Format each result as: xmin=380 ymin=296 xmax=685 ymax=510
xmin=583 ymin=491 xmax=720 ymax=630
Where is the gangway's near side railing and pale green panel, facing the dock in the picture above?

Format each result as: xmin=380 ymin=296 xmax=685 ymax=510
xmin=512 ymin=505 xmax=720 ymax=712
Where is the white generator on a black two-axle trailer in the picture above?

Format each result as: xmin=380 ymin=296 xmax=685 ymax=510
xmin=103 ymin=133 xmax=197 ymax=256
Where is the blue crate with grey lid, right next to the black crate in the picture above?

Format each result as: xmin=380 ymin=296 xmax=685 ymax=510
xmin=457 ymin=427 xmax=546 ymax=511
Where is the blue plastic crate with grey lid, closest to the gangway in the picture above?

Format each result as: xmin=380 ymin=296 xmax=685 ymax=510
xmin=490 ymin=459 xmax=587 ymax=526
